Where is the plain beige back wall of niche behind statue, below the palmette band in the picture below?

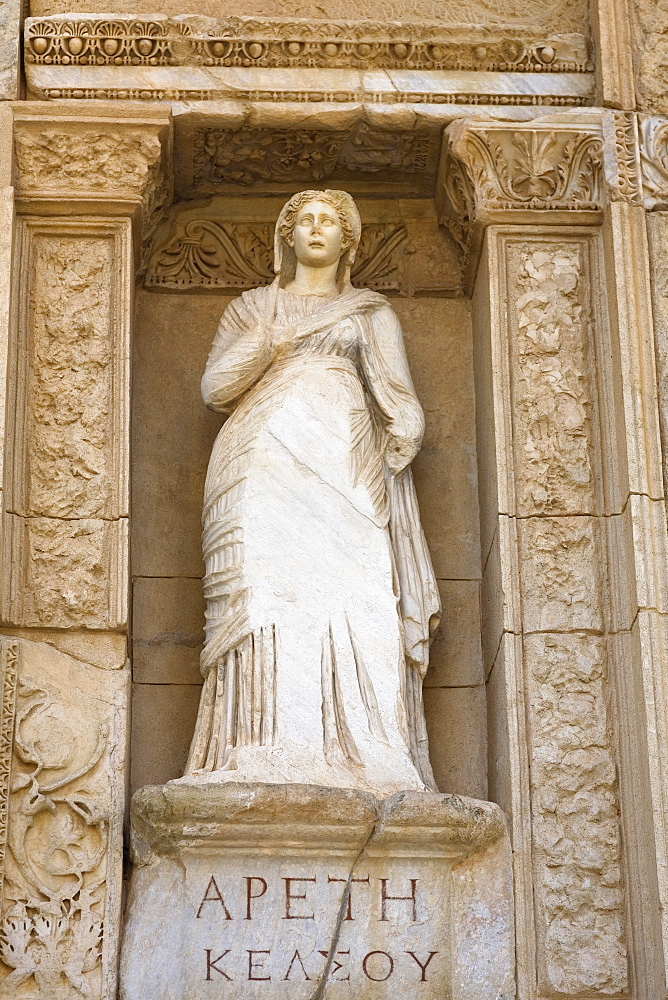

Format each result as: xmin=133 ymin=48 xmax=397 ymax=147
xmin=131 ymin=290 xmax=487 ymax=798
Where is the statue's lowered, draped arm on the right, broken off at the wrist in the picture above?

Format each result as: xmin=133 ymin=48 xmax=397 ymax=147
xmin=360 ymin=303 xmax=424 ymax=474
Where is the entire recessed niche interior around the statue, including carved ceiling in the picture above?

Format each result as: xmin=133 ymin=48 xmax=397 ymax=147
xmin=131 ymin=120 xmax=487 ymax=799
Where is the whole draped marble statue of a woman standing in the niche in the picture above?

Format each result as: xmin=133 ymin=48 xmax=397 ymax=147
xmin=182 ymin=191 xmax=440 ymax=795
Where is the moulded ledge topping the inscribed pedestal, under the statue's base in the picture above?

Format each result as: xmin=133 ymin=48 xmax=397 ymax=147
xmin=132 ymin=779 xmax=505 ymax=864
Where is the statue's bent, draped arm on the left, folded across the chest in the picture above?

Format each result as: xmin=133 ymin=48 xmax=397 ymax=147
xmin=202 ymin=297 xmax=272 ymax=413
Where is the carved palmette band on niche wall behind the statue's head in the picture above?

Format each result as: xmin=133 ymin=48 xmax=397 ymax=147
xmin=145 ymin=219 xmax=410 ymax=292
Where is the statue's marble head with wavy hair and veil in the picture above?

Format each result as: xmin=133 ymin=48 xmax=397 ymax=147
xmin=274 ymin=190 xmax=361 ymax=287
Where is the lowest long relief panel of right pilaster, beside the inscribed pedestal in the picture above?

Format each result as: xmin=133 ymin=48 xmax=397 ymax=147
xmin=524 ymin=632 xmax=628 ymax=996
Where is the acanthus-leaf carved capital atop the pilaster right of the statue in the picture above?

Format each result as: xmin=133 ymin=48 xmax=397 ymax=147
xmin=437 ymin=119 xmax=603 ymax=287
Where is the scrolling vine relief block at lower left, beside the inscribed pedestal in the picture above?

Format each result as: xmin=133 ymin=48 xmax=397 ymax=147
xmin=0 ymin=640 xmax=122 ymax=1000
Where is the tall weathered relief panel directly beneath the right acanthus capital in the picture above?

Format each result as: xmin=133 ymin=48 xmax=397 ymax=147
xmin=508 ymin=242 xmax=596 ymax=515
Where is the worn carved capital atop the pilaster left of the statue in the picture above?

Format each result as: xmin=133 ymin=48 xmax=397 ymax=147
xmin=14 ymin=102 xmax=171 ymax=218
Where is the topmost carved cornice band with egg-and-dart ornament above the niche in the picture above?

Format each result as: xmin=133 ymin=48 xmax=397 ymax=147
xmin=25 ymin=15 xmax=593 ymax=73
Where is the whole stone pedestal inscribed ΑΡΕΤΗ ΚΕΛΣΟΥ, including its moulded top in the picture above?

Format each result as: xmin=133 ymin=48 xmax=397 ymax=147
xmin=121 ymin=782 xmax=514 ymax=1000
